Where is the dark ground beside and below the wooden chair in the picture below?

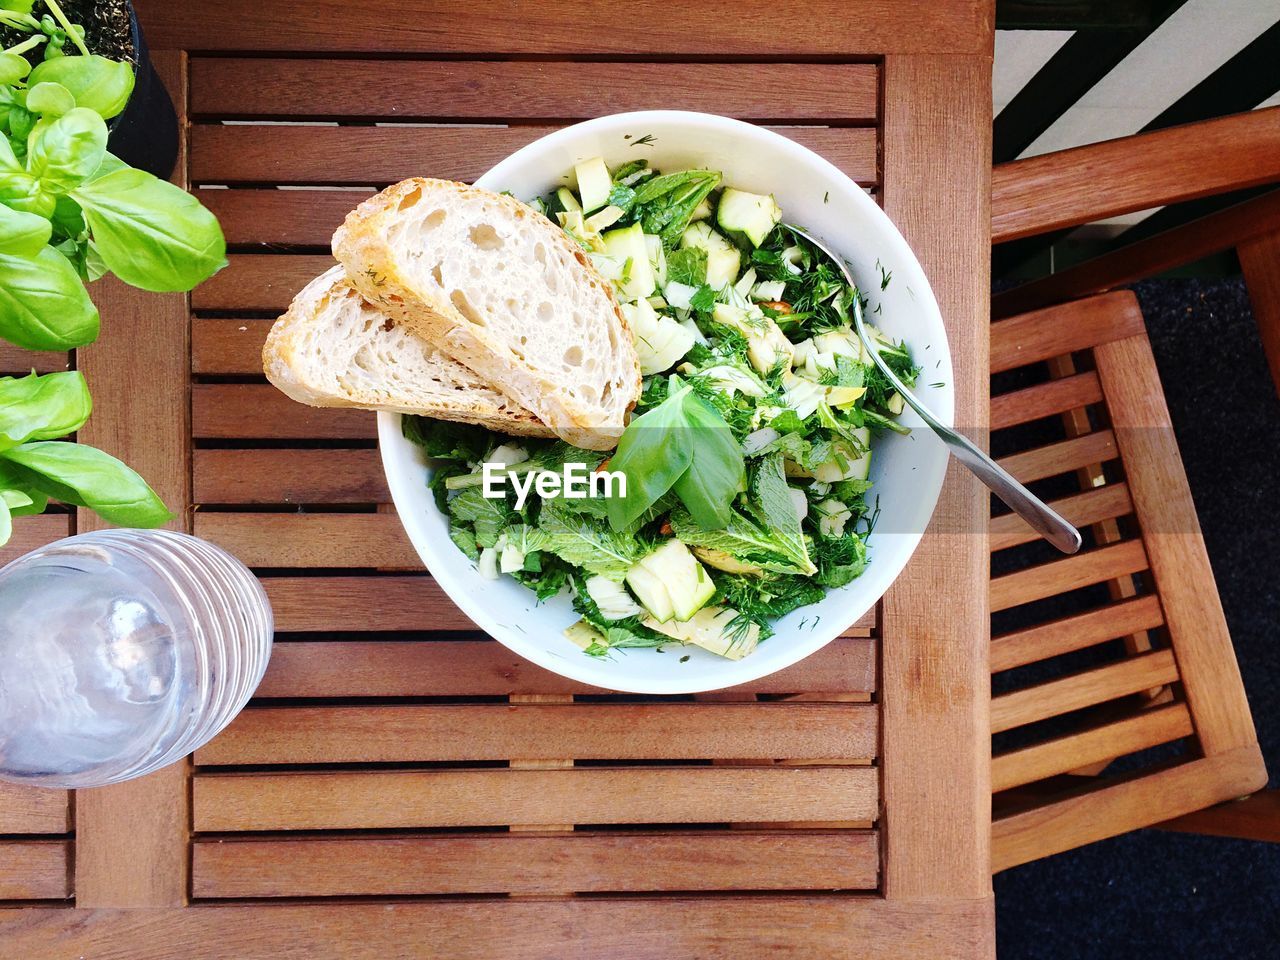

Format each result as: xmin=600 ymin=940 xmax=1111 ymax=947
xmin=995 ymin=279 xmax=1280 ymax=960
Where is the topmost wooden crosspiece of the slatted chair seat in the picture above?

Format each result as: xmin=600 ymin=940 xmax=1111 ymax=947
xmin=991 ymin=291 xmax=1147 ymax=374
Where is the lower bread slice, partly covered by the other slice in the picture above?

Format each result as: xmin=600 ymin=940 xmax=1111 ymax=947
xmin=262 ymin=266 xmax=554 ymax=436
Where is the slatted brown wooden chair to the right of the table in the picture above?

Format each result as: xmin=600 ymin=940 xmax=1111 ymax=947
xmin=991 ymin=108 xmax=1280 ymax=870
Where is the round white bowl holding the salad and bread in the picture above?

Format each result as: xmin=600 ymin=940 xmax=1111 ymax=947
xmin=378 ymin=110 xmax=954 ymax=694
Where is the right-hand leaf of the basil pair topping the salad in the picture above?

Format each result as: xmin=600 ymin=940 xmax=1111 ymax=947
xmin=670 ymin=393 xmax=742 ymax=530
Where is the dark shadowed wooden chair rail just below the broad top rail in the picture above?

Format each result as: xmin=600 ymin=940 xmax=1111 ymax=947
xmin=991 ymin=191 xmax=1280 ymax=317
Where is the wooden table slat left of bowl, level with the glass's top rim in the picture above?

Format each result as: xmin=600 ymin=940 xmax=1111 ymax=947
xmin=195 ymin=511 xmax=422 ymax=570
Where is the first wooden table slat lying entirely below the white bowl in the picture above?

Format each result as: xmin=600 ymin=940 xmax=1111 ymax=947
xmin=196 ymin=703 xmax=878 ymax=765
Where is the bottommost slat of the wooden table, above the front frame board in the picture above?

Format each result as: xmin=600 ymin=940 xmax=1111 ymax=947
xmin=192 ymin=831 xmax=879 ymax=897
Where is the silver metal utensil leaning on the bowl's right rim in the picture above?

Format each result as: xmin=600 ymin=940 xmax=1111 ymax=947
xmin=782 ymin=224 xmax=1080 ymax=553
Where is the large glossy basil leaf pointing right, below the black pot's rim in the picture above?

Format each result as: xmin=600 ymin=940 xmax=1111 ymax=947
xmin=72 ymin=168 xmax=227 ymax=293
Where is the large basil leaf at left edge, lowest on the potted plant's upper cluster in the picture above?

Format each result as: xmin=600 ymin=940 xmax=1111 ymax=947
xmin=0 ymin=247 xmax=99 ymax=349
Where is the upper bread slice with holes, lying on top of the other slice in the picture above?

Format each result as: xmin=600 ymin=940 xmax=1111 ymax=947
xmin=333 ymin=179 xmax=640 ymax=451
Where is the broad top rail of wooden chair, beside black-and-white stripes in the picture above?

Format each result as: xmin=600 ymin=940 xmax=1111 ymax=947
xmin=991 ymin=106 xmax=1280 ymax=243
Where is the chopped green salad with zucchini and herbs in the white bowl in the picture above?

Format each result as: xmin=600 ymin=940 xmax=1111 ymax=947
xmin=404 ymin=159 xmax=918 ymax=659
